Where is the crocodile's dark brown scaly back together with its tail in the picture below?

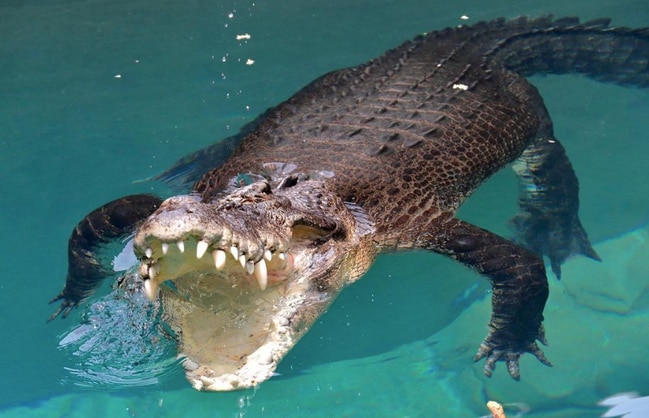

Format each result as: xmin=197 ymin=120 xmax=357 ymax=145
xmin=196 ymin=18 xmax=649 ymax=238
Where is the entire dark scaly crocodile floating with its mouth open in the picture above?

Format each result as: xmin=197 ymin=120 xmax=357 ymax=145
xmin=50 ymin=17 xmax=649 ymax=391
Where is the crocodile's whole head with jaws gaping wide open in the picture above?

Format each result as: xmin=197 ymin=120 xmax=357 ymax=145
xmin=134 ymin=171 xmax=375 ymax=391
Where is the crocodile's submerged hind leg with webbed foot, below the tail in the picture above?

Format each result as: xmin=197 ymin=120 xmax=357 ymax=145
xmin=511 ymin=136 xmax=600 ymax=278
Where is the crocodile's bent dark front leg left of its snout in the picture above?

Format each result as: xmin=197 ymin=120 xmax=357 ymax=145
xmin=49 ymin=194 xmax=162 ymax=321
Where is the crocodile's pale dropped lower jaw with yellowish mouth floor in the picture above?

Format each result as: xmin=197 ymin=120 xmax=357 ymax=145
xmin=162 ymin=275 xmax=331 ymax=391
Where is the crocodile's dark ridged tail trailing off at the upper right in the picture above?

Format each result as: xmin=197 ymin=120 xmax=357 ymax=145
xmin=485 ymin=17 xmax=649 ymax=87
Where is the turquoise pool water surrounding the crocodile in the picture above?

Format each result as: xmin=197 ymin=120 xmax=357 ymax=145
xmin=0 ymin=0 xmax=649 ymax=417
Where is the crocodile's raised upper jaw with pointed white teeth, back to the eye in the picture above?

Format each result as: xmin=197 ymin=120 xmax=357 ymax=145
xmin=134 ymin=182 xmax=344 ymax=299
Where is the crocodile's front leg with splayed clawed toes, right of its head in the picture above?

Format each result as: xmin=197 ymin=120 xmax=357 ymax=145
xmin=418 ymin=217 xmax=551 ymax=380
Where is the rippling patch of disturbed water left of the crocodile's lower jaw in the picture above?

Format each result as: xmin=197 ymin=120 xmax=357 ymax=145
xmin=59 ymin=273 xmax=181 ymax=389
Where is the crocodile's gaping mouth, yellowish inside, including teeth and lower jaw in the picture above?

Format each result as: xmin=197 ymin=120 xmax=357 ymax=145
xmin=137 ymin=226 xmax=330 ymax=391
